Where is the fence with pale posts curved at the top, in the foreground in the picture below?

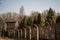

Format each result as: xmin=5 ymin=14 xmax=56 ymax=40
xmin=0 ymin=25 xmax=55 ymax=40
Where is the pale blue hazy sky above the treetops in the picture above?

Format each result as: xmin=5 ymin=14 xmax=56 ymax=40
xmin=0 ymin=0 xmax=60 ymax=15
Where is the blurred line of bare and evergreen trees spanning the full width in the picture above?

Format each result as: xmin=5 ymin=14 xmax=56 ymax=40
xmin=0 ymin=6 xmax=60 ymax=28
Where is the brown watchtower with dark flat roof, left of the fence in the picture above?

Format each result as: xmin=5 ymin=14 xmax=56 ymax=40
xmin=5 ymin=20 xmax=16 ymax=38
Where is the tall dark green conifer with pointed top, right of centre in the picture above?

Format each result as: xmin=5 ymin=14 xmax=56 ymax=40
xmin=46 ymin=8 xmax=55 ymax=25
